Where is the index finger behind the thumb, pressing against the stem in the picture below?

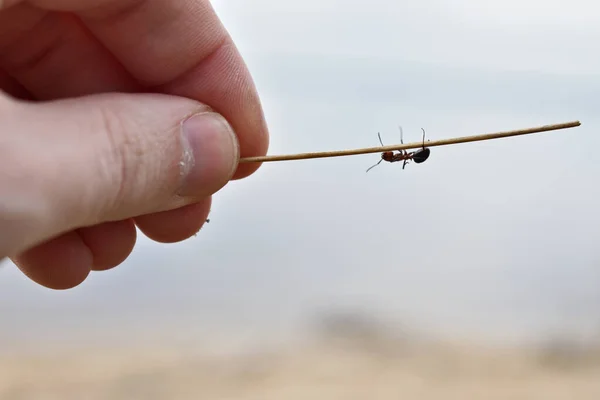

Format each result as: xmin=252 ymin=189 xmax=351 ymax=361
xmin=23 ymin=0 xmax=269 ymax=179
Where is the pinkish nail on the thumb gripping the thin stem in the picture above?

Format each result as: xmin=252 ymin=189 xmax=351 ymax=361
xmin=179 ymin=112 xmax=239 ymax=197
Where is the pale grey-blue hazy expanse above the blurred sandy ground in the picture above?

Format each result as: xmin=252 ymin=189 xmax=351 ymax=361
xmin=0 ymin=0 xmax=600 ymax=348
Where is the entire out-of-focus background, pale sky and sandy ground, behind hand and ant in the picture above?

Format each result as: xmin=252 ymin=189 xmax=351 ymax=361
xmin=0 ymin=0 xmax=600 ymax=400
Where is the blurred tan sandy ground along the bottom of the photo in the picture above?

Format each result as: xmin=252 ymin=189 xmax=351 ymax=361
xmin=0 ymin=318 xmax=600 ymax=400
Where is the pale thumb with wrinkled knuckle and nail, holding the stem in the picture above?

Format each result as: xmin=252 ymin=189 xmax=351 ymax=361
xmin=0 ymin=92 xmax=239 ymax=258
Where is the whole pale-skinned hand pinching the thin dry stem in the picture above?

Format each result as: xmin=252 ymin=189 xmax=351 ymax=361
xmin=0 ymin=0 xmax=268 ymax=289
